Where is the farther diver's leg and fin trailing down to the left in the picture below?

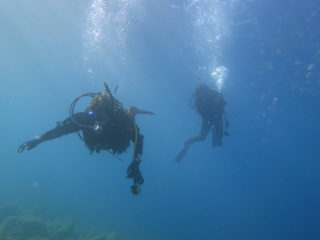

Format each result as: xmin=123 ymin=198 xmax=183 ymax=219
xmin=174 ymin=119 xmax=212 ymax=162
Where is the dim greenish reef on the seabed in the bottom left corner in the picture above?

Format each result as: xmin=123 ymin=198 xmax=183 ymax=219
xmin=0 ymin=204 xmax=120 ymax=240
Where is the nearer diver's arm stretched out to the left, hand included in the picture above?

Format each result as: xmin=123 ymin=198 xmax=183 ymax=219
xmin=18 ymin=112 xmax=91 ymax=153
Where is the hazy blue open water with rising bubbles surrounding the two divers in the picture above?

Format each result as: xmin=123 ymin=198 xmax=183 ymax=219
xmin=0 ymin=0 xmax=320 ymax=240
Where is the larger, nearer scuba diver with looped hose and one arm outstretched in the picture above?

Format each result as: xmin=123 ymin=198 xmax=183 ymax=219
xmin=18 ymin=83 xmax=154 ymax=195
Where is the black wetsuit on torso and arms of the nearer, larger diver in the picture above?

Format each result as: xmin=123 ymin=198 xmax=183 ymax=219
xmin=40 ymin=109 xmax=143 ymax=158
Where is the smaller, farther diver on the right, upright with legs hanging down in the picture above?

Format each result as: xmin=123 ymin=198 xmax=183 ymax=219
xmin=175 ymin=84 xmax=229 ymax=162
